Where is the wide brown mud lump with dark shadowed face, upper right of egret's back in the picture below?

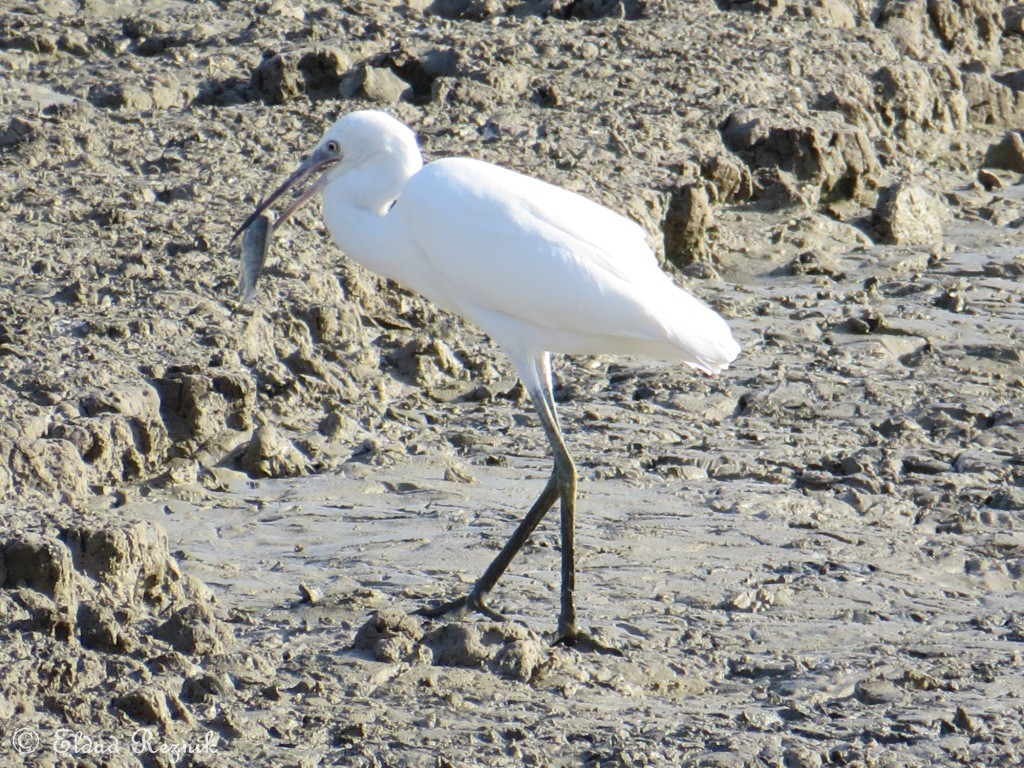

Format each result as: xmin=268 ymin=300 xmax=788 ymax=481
xmin=720 ymin=110 xmax=880 ymax=203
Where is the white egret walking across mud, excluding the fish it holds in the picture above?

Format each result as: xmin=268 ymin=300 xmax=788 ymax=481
xmin=236 ymin=111 xmax=739 ymax=644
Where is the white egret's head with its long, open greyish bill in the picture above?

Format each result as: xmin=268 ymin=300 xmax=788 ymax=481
xmin=231 ymin=110 xmax=421 ymax=241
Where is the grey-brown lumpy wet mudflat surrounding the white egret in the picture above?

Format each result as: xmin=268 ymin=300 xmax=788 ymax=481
xmin=0 ymin=0 xmax=1024 ymax=768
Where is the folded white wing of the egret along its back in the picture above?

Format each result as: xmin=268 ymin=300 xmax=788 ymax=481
xmin=394 ymin=160 xmax=724 ymax=364
